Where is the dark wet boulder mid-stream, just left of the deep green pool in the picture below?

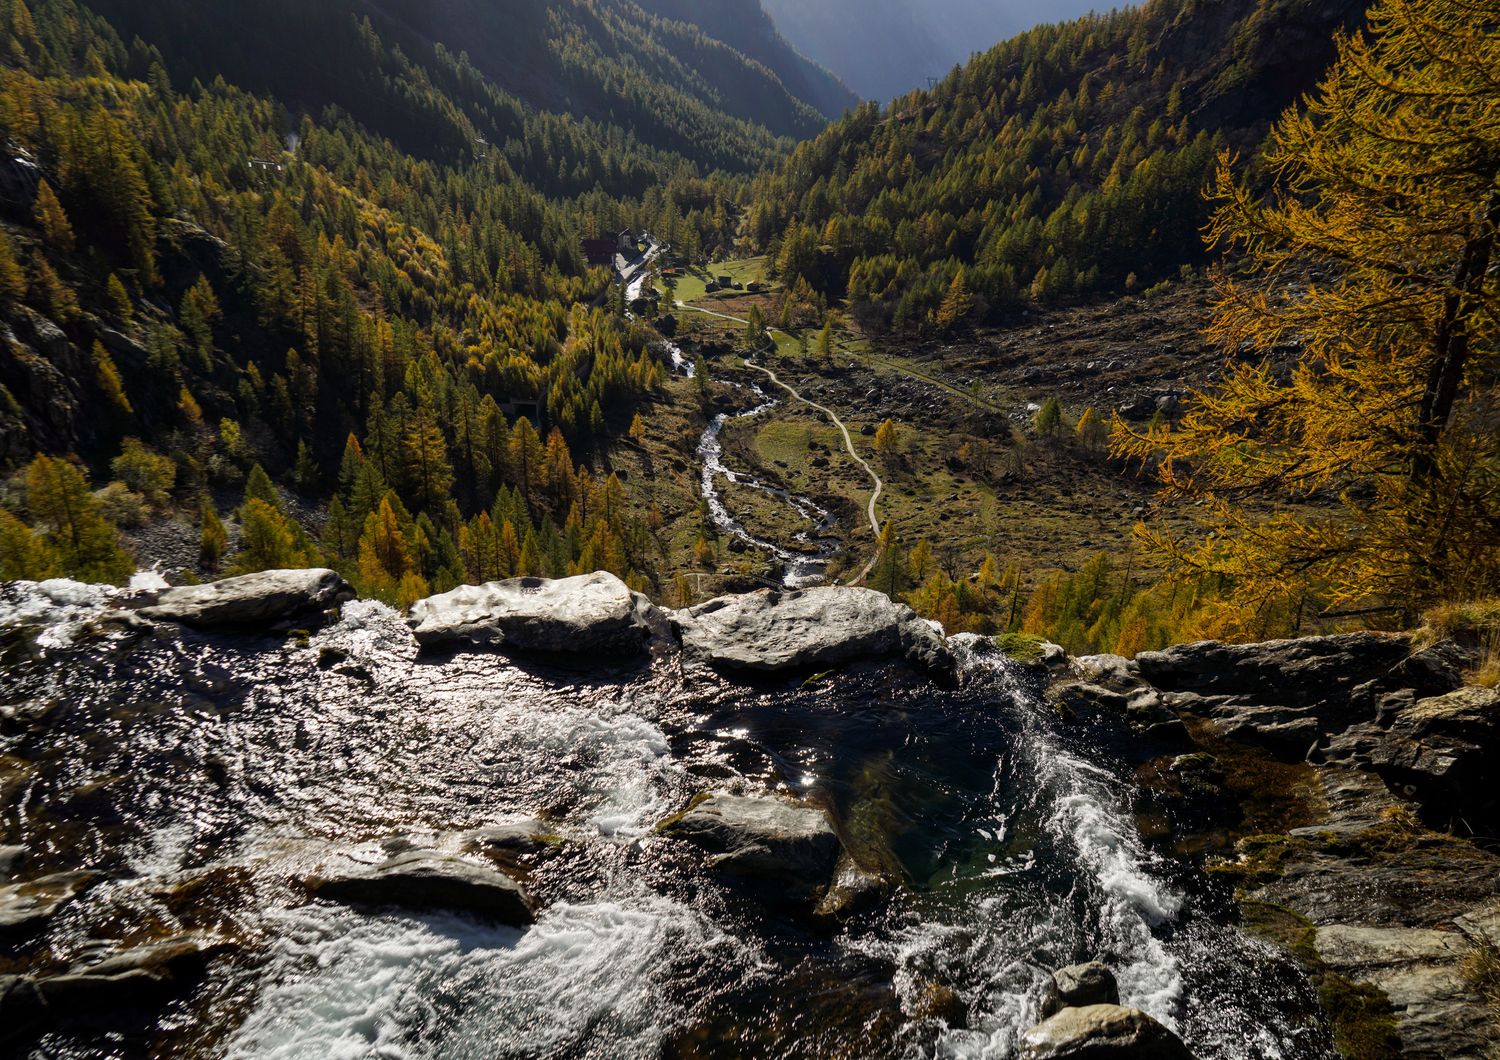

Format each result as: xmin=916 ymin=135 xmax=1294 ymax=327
xmin=660 ymin=795 xmax=842 ymax=900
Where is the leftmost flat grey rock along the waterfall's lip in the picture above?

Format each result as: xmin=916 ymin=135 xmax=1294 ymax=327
xmin=140 ymin=568 xmax=354 ymax=630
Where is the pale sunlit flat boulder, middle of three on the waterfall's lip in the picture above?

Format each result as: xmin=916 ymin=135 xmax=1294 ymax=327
xmin=410 ymin=573 xmax=660 ymax=657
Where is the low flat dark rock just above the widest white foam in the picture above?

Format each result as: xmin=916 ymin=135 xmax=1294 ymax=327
xmin=308 ymin=850 xmax=534 ymax=927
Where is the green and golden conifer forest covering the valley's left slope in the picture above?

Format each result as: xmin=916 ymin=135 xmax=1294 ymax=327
xmin=0 ymin=0 xmax=774 ymax=600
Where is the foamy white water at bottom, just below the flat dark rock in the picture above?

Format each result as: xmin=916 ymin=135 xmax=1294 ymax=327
xmin=227 ymin=894 xmax=740 ymax=1060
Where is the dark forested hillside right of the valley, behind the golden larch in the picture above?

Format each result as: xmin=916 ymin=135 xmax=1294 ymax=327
xmin=750 ymin=0 xmax=1364 ymax=331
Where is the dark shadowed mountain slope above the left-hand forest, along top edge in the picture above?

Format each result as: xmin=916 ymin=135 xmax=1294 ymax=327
xmin=82 ymin=0 xmax=825 ymax=173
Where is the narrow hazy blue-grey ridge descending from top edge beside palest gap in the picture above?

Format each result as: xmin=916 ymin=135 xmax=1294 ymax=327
xmin=636 ymin=0 xmax=860 ymax=118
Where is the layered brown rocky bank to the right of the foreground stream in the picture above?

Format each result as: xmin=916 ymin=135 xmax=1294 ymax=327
xmin=1049 ymin=633 xmax=1500 ymax=1060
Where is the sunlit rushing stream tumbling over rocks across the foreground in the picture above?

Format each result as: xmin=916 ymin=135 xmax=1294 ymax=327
xmin=0 ymin=583 xmax=1328 ymax=1060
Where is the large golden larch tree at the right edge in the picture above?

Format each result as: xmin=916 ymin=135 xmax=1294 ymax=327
xmin=1113 ymin=0 xmax=1500 ymax=628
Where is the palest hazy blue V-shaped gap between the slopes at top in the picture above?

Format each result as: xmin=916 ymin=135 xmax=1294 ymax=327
xmin=762 ymin=0 xmax=1128 ymax=102
